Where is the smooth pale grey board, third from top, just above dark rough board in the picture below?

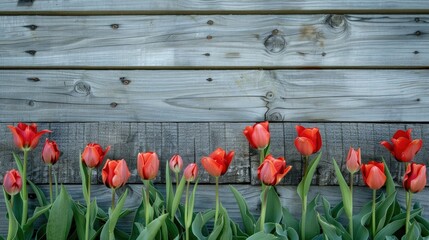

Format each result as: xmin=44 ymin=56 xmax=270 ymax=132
xmin=0 ymin=69 xmax=429 ymax=122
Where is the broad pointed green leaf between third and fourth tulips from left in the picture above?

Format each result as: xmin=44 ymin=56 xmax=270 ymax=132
xmin=46 ymin=186 xmax=73 ymax=240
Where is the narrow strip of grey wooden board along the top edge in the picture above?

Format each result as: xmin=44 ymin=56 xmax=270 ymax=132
xmin=0 ymin=0 xmax=429 ymax=14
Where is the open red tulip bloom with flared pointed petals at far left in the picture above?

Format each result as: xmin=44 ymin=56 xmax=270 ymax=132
xmin=7 ymin=123 xmax=52 ymax=150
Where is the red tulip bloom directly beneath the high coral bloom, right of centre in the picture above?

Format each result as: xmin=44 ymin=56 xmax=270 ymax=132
xmin=258 ymin=154 xmax=292 ymax=186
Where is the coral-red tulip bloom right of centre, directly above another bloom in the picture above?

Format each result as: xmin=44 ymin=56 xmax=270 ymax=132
xmin=243 ymin=121 xmax=270 ymax=150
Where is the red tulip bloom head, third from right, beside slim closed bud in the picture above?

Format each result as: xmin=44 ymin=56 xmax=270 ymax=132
xmin=361 ymin=161 xmax=386 ymax=190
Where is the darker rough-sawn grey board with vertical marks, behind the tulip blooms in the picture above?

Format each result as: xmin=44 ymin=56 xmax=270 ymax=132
xmin=0 ymin=122 xmax=429 ymax=185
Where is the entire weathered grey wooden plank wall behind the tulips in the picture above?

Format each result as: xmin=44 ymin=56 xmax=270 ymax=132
xmin=0 ymin=0 xmax=429 ymax=235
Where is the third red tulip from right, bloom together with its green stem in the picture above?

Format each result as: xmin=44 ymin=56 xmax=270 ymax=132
xmin=361 ymin=161 xmax=386 ymax=238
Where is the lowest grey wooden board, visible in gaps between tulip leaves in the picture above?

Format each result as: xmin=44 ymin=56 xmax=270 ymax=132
xmin=0 ymin=184 xmax=429 ymax=236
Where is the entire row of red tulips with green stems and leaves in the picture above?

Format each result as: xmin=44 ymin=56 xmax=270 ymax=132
xmin=3 ymin=122 xmax=429 ymax=240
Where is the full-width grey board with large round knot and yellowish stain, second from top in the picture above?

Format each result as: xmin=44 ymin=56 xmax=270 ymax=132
xmin=0 ymin=14 xmax=429 ymax=68
